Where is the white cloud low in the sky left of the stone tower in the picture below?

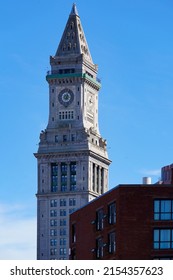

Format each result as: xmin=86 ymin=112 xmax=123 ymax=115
xmin=0 ymin=204 xmax=36 ymax=260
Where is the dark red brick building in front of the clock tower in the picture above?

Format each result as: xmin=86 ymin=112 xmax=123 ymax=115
xmin=70 ymin=184 xmax=173 ymax=260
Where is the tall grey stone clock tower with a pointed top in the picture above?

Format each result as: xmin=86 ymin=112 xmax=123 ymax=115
xmin=35 ymin=4 xmax=110 ymax=259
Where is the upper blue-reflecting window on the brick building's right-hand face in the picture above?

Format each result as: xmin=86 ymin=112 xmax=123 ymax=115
xmin=154 ymin=199 xmax=173 ymax=220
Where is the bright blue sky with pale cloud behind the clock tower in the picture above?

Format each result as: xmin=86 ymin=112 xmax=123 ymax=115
xmin=0 ymin=0 xmax=173 ymax=259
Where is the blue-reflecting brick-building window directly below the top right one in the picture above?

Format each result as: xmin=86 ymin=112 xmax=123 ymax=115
xmin=154 ymin=229 xmax=173 ymax=249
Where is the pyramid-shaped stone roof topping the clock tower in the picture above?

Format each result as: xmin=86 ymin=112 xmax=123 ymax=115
xmin=55 ymin=4 xmax=93 ymax=63
